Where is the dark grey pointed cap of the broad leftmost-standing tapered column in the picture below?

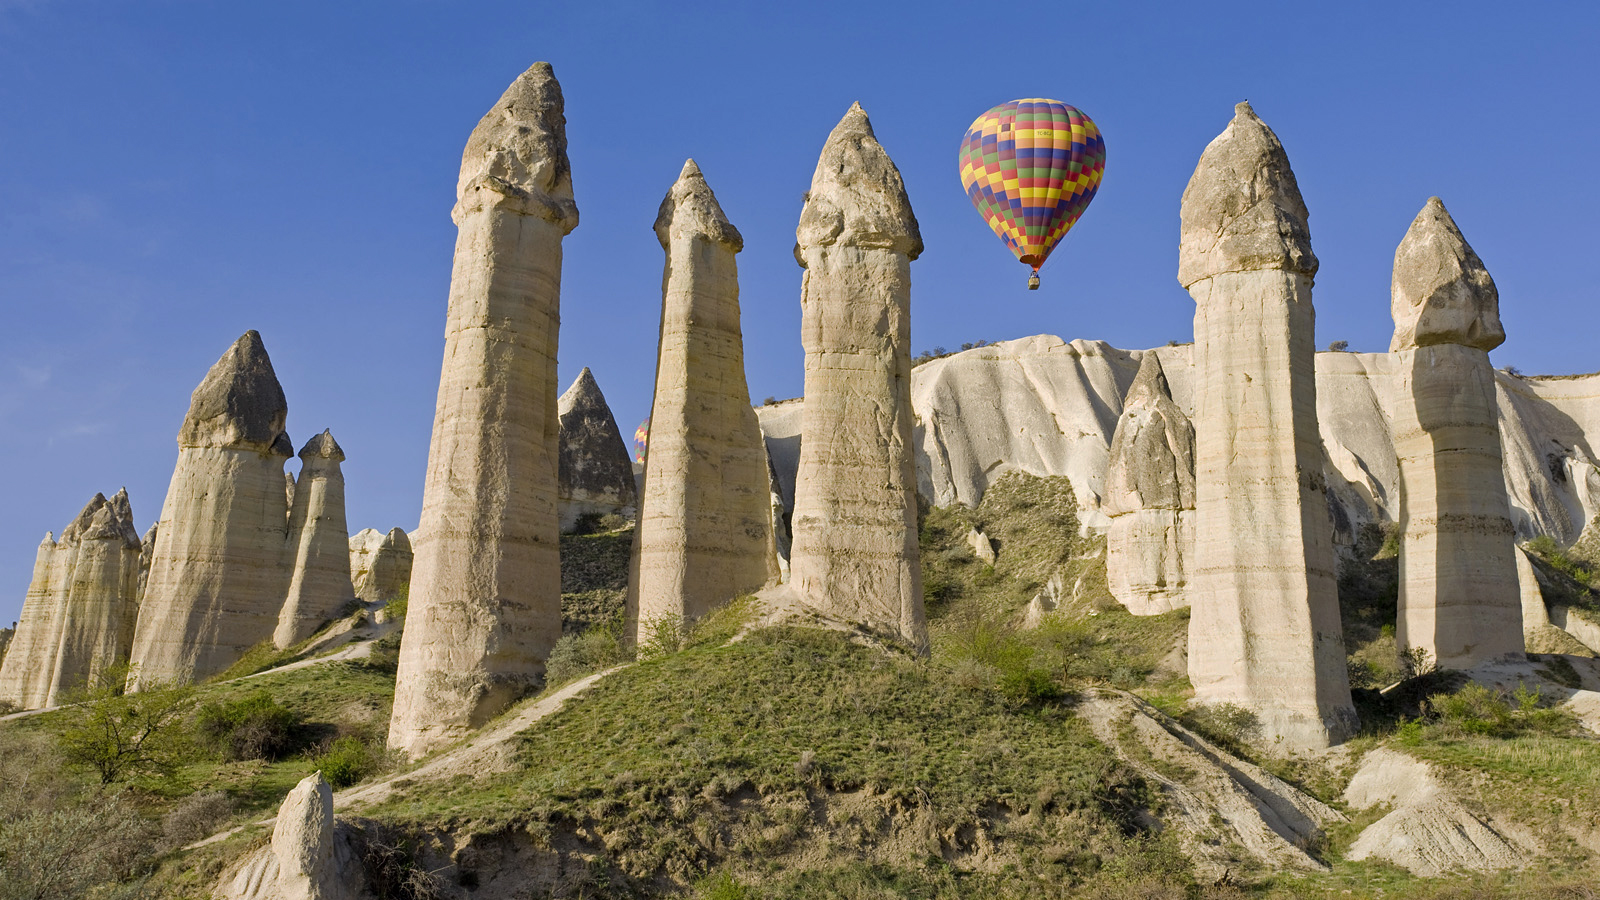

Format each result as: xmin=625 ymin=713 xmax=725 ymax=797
xmin=178 ymin=331 xmax=290 ymax=456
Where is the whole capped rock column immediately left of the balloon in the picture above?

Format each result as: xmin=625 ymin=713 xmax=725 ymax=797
xmin=789 ymin=104 xmax=926 ymax=647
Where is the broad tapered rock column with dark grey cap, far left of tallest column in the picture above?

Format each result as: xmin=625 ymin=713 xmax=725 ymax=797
xmin=128 ymin=331 xmax=293 ymax=689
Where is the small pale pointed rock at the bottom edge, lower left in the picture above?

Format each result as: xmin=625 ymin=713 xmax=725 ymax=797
xmin=216 ymin=772 xmax=355 ymax=900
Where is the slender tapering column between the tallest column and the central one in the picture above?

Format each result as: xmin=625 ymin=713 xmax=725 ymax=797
xmin=627 ymin=160 xmax=778 ymax=637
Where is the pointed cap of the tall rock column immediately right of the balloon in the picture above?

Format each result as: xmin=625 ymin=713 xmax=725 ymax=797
xmin=1178 ymin=102 xmax=1317 ymax=288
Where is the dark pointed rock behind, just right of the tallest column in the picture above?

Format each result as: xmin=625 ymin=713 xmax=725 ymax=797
xmin=557 ymin=367 xmax=638 ymax=532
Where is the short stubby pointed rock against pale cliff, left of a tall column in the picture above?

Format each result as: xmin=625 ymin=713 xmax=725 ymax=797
xmin=1104 ymin=351 xmax=1195 ymax=615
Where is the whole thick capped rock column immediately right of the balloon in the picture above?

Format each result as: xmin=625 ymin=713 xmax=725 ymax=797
xmin=1178 ymin=102 xmax=1357 ymax=749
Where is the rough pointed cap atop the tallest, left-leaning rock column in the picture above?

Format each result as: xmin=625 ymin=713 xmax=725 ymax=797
xmin=453 ymin=62 xmax=578 ymax=234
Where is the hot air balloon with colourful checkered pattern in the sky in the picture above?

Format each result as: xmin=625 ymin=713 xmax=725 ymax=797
xmin=960 ymin=98 xmax=1106 ymax=290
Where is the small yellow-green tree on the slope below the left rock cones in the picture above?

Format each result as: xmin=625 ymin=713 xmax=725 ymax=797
xmin=61 ymin=684 xmax=194 ymax=785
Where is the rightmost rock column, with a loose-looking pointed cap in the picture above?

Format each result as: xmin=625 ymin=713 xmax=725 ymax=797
xmin=1389 ymin=197 xmax=1523 ymax=669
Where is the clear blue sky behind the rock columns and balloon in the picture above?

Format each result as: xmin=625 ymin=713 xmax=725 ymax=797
xmin=0 ymin=0 xmax=1600 ymax=623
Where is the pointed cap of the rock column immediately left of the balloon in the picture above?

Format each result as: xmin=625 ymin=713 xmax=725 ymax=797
xmin=795 ymin=102 xmax=922 ymax=267
